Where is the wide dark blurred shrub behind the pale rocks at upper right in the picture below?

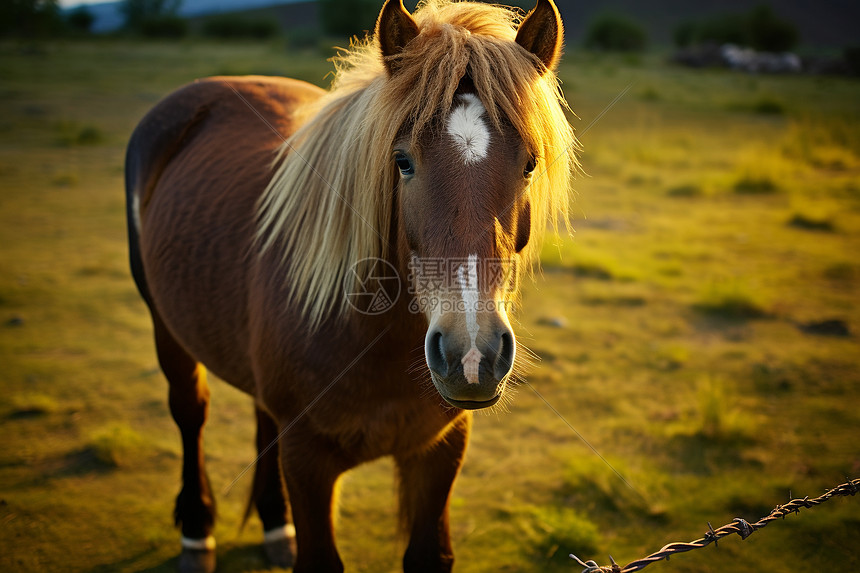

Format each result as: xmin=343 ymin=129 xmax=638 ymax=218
xmin=673 ymin=4 xmax=800 ymax=52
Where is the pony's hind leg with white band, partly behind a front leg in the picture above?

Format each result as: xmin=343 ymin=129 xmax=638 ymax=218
xmin=252 ymin=408 xmax=296 ymax=569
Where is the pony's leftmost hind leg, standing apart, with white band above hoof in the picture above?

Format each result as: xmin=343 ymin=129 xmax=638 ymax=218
xmin=152 ymin=310 xmax=215 ymax=573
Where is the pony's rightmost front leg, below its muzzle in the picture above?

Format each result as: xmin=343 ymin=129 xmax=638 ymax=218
xmin=395 ymin=413 xmax=472 ymax=573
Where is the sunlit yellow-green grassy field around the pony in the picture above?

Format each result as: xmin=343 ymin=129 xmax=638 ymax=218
xmin=0 ymin=36 xmax=860 ymax=573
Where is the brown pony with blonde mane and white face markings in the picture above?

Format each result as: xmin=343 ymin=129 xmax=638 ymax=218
xmin=126 ymin=0 xmax=576 ymax=573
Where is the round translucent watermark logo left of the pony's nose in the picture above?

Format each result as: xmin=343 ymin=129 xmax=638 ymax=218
xmin=344 ymin=257 xmax=400 ymax=315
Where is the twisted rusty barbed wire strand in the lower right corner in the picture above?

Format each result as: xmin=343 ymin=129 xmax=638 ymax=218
xmin=570 ymin=479 xmax=860 ymax=573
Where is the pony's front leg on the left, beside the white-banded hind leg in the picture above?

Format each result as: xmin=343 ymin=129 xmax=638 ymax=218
xmin=281 ymin=422 xmax=354 ymax=573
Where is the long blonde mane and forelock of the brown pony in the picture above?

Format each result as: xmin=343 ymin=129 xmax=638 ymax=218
xmin=257 ymin=0 xmax=578 ymax=328
